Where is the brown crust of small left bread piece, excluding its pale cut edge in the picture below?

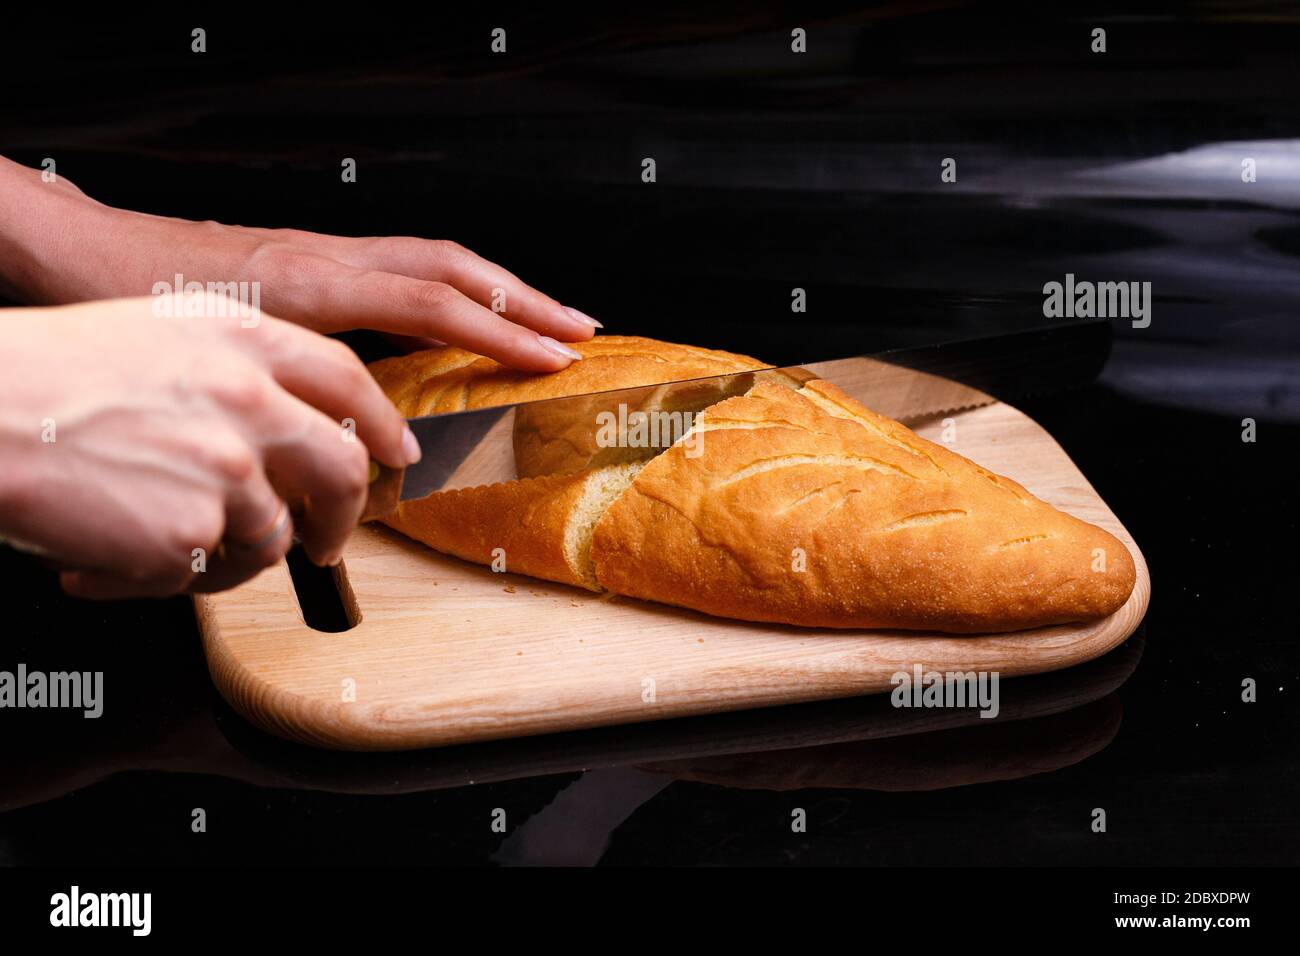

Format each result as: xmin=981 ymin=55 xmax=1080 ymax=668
xmin=384 ymin=475 xmax=599 ymax=591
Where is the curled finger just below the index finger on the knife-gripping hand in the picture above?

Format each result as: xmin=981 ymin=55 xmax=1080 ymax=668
xmin=250 ymin=392 xmax=371 ymax=566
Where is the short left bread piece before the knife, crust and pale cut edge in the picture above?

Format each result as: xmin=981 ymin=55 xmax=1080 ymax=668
xmin=384 ymin=462 xmax=642 ymax=591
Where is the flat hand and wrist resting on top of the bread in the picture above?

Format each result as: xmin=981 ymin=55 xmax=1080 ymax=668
xmin=0 ymin=157 xmax=599 ymax=372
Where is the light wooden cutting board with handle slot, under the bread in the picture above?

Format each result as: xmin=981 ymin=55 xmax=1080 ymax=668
xmin=195 ymin=403 xmax=1151 ymax=750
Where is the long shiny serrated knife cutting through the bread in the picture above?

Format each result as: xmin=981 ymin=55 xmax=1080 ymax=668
xmin=361 ymin=321 xmax=1110 ymax=522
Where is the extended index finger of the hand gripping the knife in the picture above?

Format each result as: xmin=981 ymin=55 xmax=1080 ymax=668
xmin=233 ymin=316 xmax=420 ymax=468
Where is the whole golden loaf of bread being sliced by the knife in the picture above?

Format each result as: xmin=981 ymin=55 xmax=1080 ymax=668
xmin=376 ymin=337 xmax=1135 ymax=633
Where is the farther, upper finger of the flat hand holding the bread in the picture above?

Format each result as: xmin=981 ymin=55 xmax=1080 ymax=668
xmin=334 ymin=237 xmax=601 ymax=342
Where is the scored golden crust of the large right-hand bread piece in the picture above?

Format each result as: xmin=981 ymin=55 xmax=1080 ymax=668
xmin=592 ymin=381 xmax=1135 ymax=632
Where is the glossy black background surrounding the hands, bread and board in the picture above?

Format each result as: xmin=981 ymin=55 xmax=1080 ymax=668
xmin=0 ymin=4 xmax=1300 ymax=865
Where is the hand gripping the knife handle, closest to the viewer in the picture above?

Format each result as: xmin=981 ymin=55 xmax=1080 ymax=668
xmin=0 ymin=295 xmax=420 ymax=598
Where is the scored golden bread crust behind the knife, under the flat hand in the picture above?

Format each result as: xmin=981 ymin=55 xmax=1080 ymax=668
xmin=369 ymin=336 xmax=771 ymax=419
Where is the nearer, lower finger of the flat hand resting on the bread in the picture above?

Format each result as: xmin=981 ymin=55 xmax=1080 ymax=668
xmin=253 ymin=254 xmax=582 ymax=372
